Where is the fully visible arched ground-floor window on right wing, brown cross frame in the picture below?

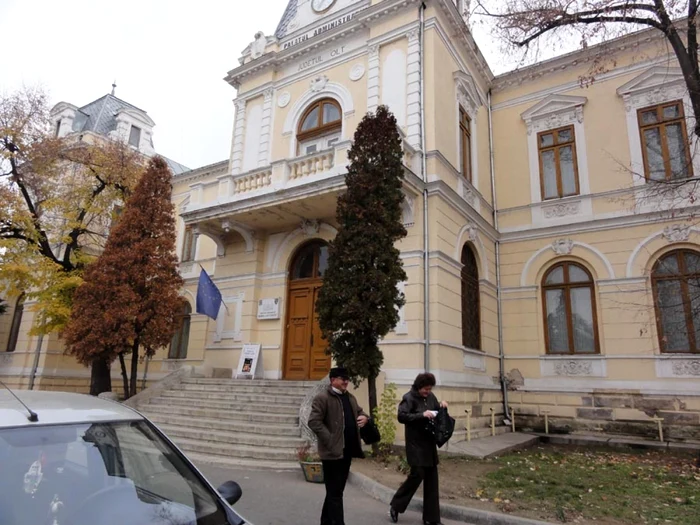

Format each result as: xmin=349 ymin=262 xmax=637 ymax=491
xmin=542 ymin=262 xmax=599 ymax=354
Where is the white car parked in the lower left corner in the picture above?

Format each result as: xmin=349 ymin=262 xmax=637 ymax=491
xmin=0 ymin=385 xmax=252 ymax=525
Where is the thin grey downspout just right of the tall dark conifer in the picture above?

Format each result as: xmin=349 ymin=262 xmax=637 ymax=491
xmin=418 ymin=2 xmax=430 ymax=372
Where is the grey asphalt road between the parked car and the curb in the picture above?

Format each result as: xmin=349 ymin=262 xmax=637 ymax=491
xmin=199 ymin=465 xmax=464 ymax=525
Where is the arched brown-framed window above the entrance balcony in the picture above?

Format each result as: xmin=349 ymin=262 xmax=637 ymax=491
xmin=297 ymin=98 xmax=343 ymax=155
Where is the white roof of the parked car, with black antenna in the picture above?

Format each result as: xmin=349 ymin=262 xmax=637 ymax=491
xmin=0 ymin=387 xmax=144 ymax=429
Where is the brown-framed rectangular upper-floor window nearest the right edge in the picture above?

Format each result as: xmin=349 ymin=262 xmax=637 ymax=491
xmin=637 ymin=100 xmax=693 ymax=181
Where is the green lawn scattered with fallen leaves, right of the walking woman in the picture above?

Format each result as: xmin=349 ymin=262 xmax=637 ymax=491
xmin=482 ymin=446 xmax=700 ymax=525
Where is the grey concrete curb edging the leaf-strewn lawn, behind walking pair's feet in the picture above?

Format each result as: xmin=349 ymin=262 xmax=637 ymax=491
xmin=348 ymin=472 xmax=555 ymax=525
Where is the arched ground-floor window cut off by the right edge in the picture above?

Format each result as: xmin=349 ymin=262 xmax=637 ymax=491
xmin=651 ymin=250 xmax=700 ymax=353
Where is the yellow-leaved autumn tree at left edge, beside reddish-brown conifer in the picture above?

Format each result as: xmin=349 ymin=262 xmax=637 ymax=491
xmin=0 ymin=88 xmax=144 ymax=394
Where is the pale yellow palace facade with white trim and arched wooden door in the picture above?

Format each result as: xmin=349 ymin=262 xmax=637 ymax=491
xmin=0 ymin=0 xmax=700 ymax=437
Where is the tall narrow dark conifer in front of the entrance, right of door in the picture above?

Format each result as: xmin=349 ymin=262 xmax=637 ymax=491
xmin=316 ymin=106 xmax=406 ymax=413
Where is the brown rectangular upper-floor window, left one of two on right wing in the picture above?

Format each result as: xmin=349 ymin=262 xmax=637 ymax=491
xmin=537 ymin=126 xmax=579 ymax=200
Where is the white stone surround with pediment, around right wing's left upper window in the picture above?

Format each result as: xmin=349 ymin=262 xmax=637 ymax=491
xmin=520 ymin=94 xmax=593 ymax=224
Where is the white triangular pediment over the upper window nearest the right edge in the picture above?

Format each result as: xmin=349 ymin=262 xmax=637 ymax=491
xmin=617 ymin=66 xmax=687 ymax=112
